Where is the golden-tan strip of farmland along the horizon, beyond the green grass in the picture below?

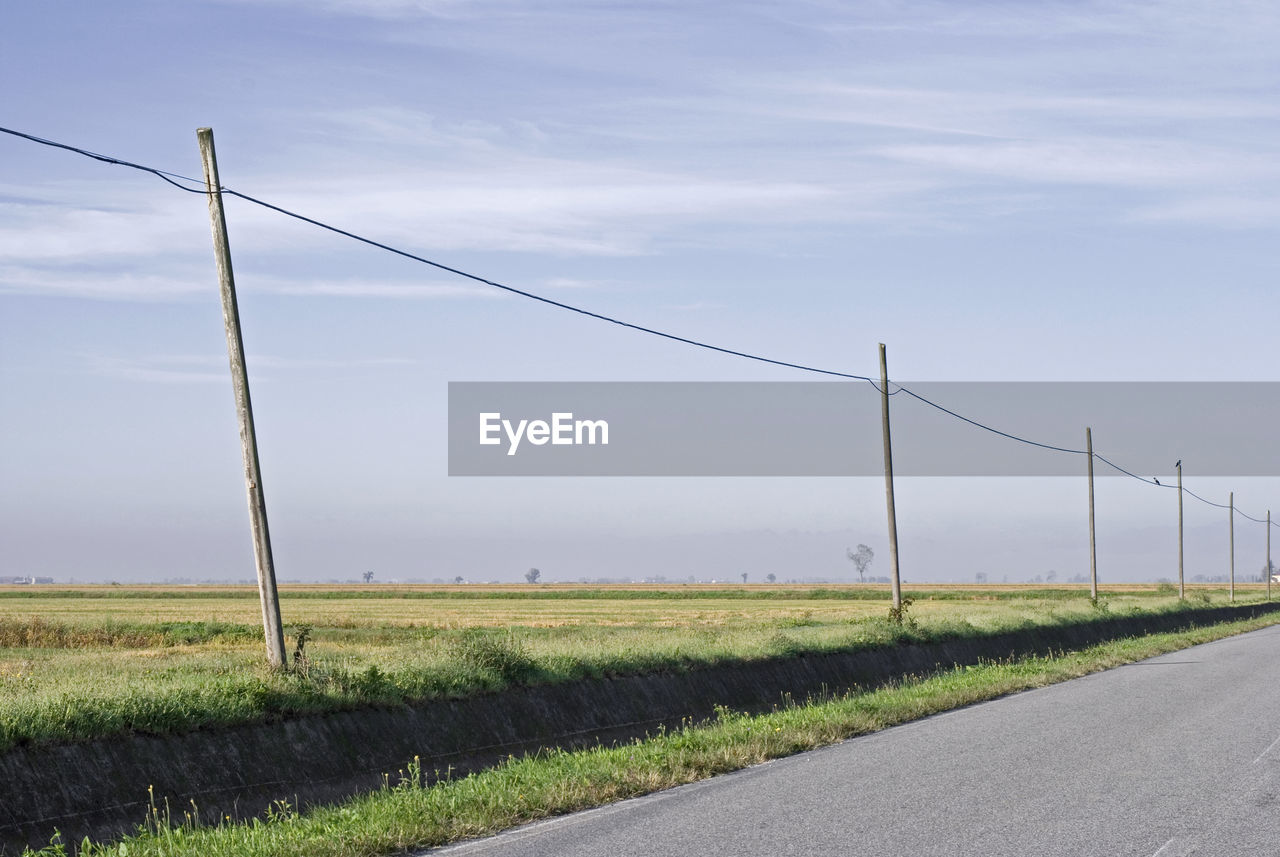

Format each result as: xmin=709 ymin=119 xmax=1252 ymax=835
xmin=0 ymin=585 xmax=1228 ymax=629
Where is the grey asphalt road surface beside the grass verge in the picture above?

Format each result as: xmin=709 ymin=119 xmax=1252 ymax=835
xmin=431 ymin=627 xmax=1280 ymax=857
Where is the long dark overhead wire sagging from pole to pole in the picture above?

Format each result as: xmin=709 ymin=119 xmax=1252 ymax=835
xmin=0 ymin=121 xmax=1280 ymax=527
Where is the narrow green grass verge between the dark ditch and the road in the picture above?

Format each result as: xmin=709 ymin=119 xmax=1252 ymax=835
xmin=27 ymin=617 xmax=1277 ymax=857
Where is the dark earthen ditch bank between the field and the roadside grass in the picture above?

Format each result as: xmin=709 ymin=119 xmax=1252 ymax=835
xmin=0 ymin=604 xmax=1280 ymax=854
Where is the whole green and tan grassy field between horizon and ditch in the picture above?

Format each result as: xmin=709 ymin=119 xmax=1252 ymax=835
xmin=0 ymin=585 xmax=1263 ymax=751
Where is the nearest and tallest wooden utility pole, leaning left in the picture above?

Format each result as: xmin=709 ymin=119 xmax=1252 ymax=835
xmin=196 ymin=128 xmax=284 ymax=668
